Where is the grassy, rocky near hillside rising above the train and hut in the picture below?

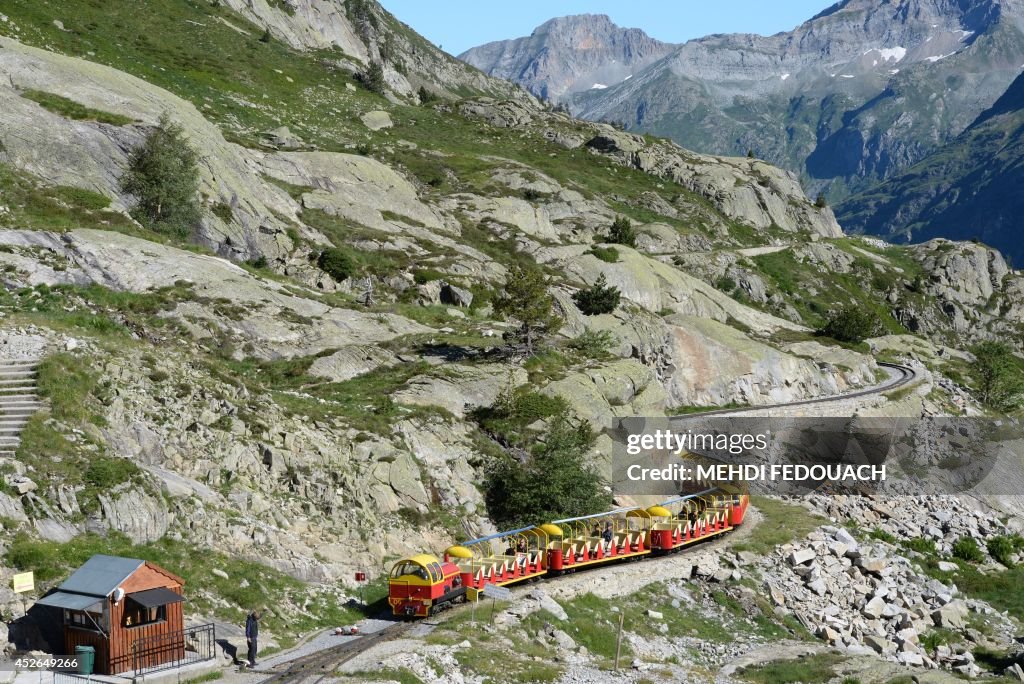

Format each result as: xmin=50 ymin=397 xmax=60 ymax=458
xmin=0 ymin=0 xmax=1024 ymax=675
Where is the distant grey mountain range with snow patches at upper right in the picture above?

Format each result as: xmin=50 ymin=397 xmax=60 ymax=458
xmin=464 ymin=0 xmax=1024 ymax=201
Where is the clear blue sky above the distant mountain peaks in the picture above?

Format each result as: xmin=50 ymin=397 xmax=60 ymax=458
xmin=380 ymin=0 xmax=835 ymax=54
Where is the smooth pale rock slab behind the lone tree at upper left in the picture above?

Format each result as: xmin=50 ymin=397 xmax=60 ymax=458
xmin=0 ymin=37 xmax=296 ymax=259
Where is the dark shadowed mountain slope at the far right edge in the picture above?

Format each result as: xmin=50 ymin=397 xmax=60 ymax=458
xmin=839 ymin=71 xmax=1024 ymax=263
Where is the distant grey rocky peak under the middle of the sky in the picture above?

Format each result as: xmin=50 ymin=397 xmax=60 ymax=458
xmin=459 ymin=14 xmax=673 ymax=101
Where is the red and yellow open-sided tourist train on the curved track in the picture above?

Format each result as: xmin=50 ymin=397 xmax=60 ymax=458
xmin=388 ymin=487 xmax=750 ymax=618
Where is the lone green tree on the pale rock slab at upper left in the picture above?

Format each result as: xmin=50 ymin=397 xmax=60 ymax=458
xmin=121 ymin=114 xmax=201 ymax=238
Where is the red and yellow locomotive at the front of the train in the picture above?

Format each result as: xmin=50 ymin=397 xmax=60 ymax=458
xmin=388 ymin=553 xmax=466 ymax=617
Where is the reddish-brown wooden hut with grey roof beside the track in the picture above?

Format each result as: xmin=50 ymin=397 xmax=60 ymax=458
xmin=38 ymin=554 xmax=184 ymax=675
